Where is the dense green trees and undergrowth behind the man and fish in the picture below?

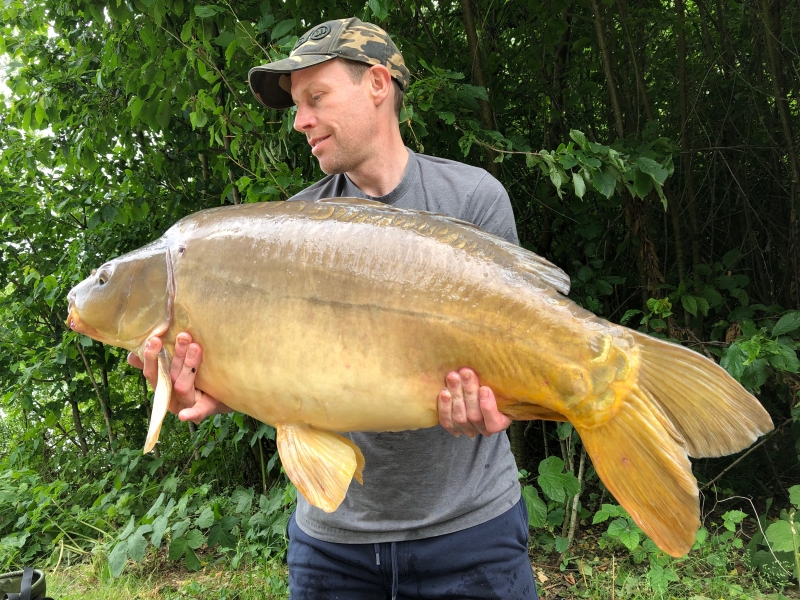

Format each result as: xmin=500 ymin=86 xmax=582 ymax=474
xmin=0 ymin=0 xmax=800 ymax=598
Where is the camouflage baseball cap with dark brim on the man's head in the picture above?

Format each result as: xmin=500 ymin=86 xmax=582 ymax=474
xmin=247 ymin=17 xmax=410 ymax=109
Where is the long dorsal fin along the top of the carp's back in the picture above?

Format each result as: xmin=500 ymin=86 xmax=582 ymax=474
xmin=310 ymin=198 xmax=570 ymax=295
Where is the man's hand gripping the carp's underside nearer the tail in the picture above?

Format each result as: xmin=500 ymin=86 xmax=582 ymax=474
xmin=437 ymin=368 xmax=511 ymax=438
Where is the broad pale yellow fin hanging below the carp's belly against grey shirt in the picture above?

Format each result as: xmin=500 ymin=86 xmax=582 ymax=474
xmin=277 ymin=425 xmax=364 ymax=512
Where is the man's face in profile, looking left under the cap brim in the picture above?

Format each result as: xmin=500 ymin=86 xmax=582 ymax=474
xmin=291 ymin=59 xmax=377 ymax=175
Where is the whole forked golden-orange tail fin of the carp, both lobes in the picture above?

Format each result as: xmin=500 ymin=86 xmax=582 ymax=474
xmin=576 ymin=332 xmax=773 ymax=556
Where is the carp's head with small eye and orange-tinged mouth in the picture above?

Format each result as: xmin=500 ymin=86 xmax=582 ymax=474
xmin=67 ymin=244 xmax=174 ymax=350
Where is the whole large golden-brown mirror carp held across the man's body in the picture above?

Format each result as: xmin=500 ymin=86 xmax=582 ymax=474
xmin=68 ymin=198 xmax=772 ymax=556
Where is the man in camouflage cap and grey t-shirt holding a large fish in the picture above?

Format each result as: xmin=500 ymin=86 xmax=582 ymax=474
xmin=129 ymin=18 xmax=537 ymax=600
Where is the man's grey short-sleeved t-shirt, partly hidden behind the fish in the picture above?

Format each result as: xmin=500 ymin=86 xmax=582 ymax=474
xmin=291 ymin=150 xmax=520 ymax=544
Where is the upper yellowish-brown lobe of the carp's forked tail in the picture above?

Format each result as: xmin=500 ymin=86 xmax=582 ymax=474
xmin=633 ymin=332 xmax=773 ymax=457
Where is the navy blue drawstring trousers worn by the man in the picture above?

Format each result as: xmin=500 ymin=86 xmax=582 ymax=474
xmin=288 ymin=499 xmax=538 ymax=600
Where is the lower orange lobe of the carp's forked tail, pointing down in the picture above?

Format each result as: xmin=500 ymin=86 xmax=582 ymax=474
xmin=578 ymin=386 xmax=700 ymax=556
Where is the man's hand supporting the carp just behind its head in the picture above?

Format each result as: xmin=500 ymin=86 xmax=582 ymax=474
xmin=128 ymin=332 xmax=233 ymax=423
